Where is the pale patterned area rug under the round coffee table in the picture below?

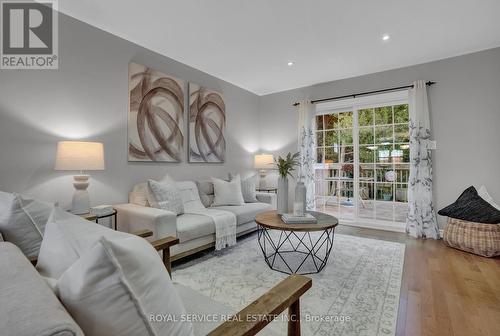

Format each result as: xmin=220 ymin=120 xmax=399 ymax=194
xmin=172 ymin=234 xmax=405 ymax=336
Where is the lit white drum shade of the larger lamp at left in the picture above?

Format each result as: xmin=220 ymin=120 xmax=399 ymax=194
xmin=54 ymin=141 xmax=104 ymax=170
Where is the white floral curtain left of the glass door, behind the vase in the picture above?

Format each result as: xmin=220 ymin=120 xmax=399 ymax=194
xmin=298 ymin=100 xmax=316 ymax=210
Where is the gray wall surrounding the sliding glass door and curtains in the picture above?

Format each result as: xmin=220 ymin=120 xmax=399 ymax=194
xmin=260 ymin=48 xmax=500 ymax=226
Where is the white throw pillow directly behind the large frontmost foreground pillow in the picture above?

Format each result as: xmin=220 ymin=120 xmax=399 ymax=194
xmin=36 ymin=207 xmax=129 ymax=279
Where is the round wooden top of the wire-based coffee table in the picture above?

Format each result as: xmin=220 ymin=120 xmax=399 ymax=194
xmin=255 ymin=210 xmax=339 ymax=232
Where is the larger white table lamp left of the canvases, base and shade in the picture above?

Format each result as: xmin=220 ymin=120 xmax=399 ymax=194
xmin=54 ymin=141 xmax=104 ymax=215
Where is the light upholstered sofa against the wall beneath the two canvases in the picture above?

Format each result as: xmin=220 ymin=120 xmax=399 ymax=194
xmin=114 ymin=181 xmax=276 ymax=260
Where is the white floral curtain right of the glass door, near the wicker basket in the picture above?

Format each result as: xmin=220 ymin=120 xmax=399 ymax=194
xmin=406 ymin=80 xmax=439 ymax=239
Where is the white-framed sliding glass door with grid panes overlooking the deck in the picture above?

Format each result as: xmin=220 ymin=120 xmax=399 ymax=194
xmin=315 ymin=92 xmax=409 ymax=226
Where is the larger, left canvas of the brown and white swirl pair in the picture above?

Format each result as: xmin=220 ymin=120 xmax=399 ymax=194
xmin=128 ymin=63 xmax=185 ymax=162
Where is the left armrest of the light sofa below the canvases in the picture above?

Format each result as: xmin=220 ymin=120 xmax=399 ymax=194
xmin=113 ymin=203 xmax=177 ymax=240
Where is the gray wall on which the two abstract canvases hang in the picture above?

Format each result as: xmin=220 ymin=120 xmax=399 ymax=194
xmin=0 ymin=14 xmax=259 ymax=207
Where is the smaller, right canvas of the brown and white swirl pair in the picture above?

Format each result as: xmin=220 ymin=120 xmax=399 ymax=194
xmin=188 ymin=83 xmax=226 ymax=163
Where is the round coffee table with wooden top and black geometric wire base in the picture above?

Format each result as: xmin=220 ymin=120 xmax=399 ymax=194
xmin=255 ymin=211 xmax=338 ymax=274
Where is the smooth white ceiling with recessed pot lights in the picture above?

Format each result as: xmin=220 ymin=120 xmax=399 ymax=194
xmin=59 ymin=0 xmax=500 ymax=95
